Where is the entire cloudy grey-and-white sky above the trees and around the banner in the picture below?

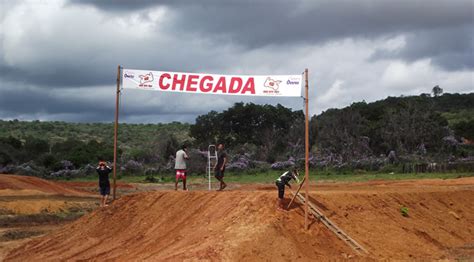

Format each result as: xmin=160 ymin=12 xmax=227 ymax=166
xmin=0 ymin=0 xmax=474 ymax=122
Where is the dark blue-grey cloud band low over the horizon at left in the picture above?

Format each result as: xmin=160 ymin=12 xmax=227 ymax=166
xmin=0 ymin=86 xmax=180 ymax=122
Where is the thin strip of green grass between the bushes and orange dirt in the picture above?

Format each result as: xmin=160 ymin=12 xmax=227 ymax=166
xmin=60 ymin=170 xmax=474 ymax=184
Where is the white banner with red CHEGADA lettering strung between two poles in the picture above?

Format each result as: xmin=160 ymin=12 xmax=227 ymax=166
xmin=122 ymin=69 xmax=303 ymax=97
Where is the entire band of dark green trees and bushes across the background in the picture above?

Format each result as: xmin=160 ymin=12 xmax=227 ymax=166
xmin=0 ymin=94 xmax=474 ymax=176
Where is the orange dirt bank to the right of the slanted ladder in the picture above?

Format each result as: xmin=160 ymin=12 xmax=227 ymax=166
xmin=311 ymin=186 xmax=474 ymax=260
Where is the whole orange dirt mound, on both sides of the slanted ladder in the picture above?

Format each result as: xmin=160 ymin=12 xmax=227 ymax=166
xmin=6 ymin=178 xmax=474 ymax=261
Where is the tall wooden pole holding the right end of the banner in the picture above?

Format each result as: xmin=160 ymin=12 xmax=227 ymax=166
xmin=304 ymin=68 xmax=309 ymax=230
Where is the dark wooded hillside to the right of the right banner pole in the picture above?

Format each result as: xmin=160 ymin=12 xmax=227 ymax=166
xmin=314 ymin=94 xmax=474 ymax=161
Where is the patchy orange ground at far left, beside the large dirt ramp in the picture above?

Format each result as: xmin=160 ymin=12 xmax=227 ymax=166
xmin=0 ymin=174 xmax=99 ymax=261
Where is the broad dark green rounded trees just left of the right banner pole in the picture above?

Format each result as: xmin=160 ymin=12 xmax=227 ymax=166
xmin=190 ymin=103 xmax=304 ymax=162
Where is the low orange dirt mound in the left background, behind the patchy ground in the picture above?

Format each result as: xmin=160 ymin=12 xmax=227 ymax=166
xmin=0 ymin=174 xmax=87 ymax=195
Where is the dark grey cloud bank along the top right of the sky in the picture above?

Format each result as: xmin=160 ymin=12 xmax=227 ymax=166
xmin=66 ymin=0 xmax=474 ymax=70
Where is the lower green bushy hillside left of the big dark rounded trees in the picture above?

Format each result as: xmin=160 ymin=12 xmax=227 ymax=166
xmin=0 ymin=120 xmax=190 ymax=174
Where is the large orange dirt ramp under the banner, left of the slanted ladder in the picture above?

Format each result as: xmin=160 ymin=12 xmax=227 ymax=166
xmin=6 ymin=191 xmax=354 ymax=261
